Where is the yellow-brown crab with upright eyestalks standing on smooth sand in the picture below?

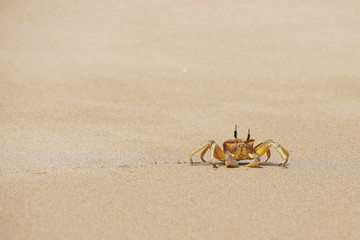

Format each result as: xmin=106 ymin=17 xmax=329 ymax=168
xmin=190 ymin=125 xmax=289 ymax=168
